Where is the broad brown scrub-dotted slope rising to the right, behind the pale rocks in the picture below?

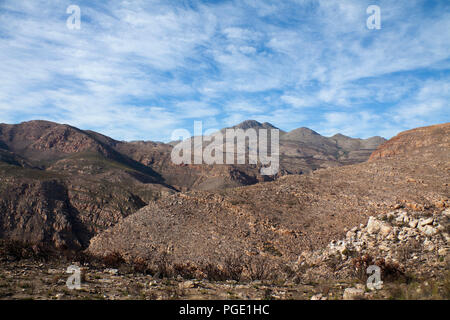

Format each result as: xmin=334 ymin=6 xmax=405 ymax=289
xmin=89 ymin=124 xmax=450 ymax=278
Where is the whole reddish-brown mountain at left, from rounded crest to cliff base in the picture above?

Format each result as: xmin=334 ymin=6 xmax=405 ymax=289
xmin=0 ymin=121 xmax=173 ymax=249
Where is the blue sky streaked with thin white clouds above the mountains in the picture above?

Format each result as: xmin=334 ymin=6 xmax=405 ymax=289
xmin=0 ymin=0 xmax=450 ymax=141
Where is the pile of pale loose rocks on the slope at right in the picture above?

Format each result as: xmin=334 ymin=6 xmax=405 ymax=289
xmin=297 ymin=208 xmax=450 ymax=279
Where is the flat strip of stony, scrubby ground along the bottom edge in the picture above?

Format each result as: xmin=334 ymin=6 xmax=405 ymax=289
xmin=0 ymin=261 xmax=450 ymax=300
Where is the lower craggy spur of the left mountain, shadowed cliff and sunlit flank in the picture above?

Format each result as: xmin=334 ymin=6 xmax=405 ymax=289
xmin=0 ymin=171 xmax=169 ymax=249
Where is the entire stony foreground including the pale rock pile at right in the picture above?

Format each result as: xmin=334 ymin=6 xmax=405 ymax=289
xmin=0 ymin=209 xmax=450 ymax=300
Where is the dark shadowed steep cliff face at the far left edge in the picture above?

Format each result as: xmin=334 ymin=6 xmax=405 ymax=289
xmin=0 ymin=180 xmax=83 ymax=248
